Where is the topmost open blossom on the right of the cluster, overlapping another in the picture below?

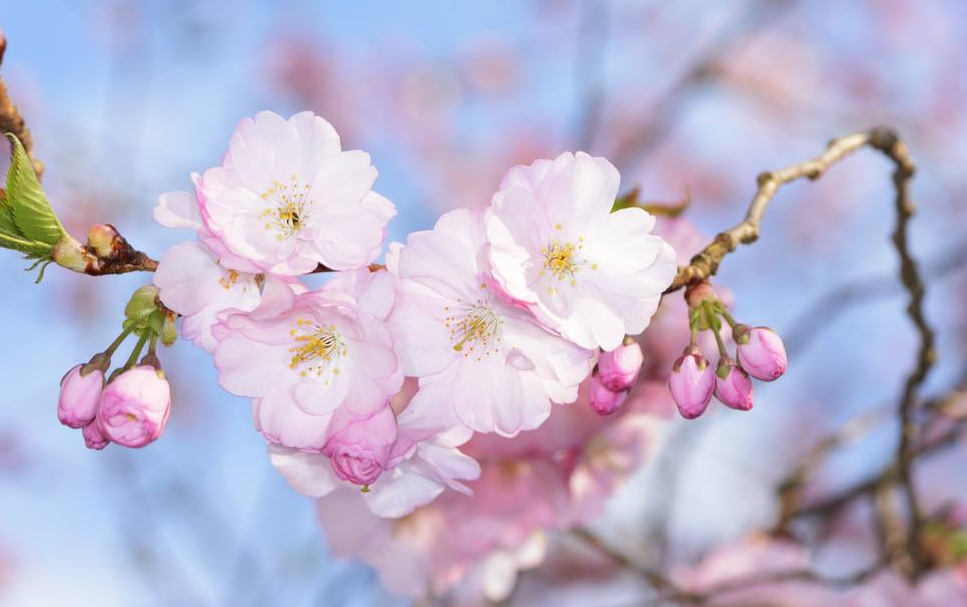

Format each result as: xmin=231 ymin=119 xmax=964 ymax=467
xmin=487 ymin=152 xmax=676 ymax=350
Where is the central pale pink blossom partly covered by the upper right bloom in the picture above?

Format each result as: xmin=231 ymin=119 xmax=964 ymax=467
xmin=390 ymin=210 xmax=592 ymax=436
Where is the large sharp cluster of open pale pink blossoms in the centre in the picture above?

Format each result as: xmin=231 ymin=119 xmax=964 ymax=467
xmin=140 ymin=112 xmax=676 ymax=517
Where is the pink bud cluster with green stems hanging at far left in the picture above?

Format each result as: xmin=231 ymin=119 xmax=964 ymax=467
xmin=57 ymin=286 xmax=177 ymax=450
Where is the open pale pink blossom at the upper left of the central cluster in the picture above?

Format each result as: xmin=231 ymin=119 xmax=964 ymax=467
xmin=198 ymin=112 xmax=396 ymax=275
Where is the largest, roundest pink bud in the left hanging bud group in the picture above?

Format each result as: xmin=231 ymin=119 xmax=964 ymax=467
xmin=97 ymin=365 xmax=171 ymax=448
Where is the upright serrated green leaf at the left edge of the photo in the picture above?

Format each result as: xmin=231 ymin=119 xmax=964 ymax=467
xmin=6 ymin=133 xmax=67 ymax=246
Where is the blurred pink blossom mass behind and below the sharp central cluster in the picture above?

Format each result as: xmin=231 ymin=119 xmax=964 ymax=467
xmin=318 ymin=380 xmax=670 ymax=605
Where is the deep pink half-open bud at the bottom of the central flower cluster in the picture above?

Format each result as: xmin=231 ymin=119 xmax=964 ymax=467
xmin=322 ymin=406 xmax=396 ymax=485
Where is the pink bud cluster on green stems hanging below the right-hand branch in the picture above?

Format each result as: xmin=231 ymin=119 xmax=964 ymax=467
xmin=668 ymin=283 xmax=787 ymax=419
